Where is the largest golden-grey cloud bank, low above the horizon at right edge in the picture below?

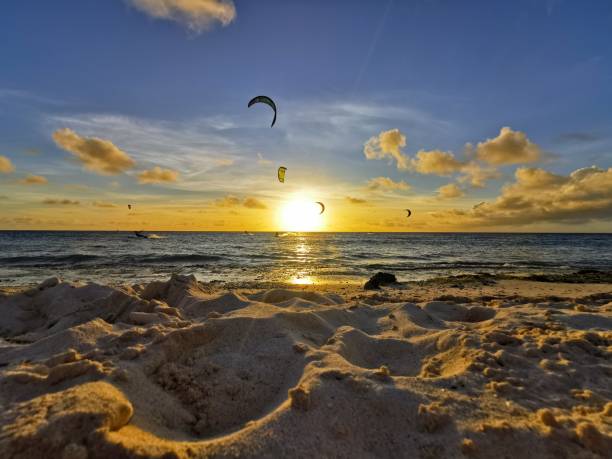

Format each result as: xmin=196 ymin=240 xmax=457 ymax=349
xmin=431 ymin=166 xmax=612 ymax=226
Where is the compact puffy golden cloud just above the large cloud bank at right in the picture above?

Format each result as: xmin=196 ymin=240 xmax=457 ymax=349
xmin=476 ymin=127 xmax=542 ymax=166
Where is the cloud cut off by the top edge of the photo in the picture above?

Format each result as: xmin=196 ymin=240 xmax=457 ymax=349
xmin=128 ymin=0 xmax=236 ymax=32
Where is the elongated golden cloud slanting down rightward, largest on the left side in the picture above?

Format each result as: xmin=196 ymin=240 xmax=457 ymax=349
xmin=53 ymin=128 xmax=135 ymax=175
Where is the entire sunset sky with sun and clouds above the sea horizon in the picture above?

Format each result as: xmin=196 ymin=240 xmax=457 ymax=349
xmin=0 ymin=0 xmax=612 ymax=232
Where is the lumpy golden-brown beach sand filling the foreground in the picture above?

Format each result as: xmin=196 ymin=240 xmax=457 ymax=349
xmin=0 ymin=275 xmax=612 ymax=459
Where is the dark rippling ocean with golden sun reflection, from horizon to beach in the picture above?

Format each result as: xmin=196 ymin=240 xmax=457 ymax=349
xmin=0 ymin=231 xmax=612 ymax=286
